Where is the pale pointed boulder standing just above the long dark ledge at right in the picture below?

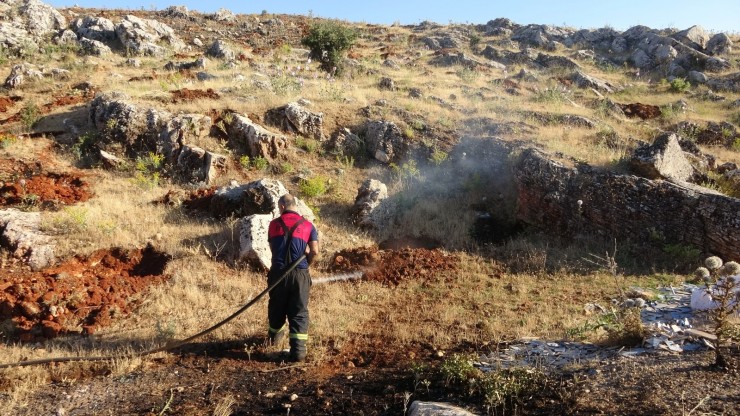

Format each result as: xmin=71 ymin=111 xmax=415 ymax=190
xmin=630 ymin=133 xmax=694 ymax=182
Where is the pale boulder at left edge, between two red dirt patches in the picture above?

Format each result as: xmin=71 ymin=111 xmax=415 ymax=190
xmin=0 ymin=208 xmax=55 ymax=270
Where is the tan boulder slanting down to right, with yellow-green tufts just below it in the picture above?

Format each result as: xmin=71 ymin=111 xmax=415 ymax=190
xmin=225 ymin=113 xmax=288 ymax=160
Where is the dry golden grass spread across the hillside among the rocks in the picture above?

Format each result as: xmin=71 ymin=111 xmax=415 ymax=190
xmin=0 ymin=11 xmax=740 ymax=415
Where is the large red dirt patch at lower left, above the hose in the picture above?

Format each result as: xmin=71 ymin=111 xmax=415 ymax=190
xmin=0 ymin=246 xmax=169 ymax=341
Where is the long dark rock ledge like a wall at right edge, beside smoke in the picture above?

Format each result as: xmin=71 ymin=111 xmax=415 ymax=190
xmin=512 ymin=149 xmax=740 ymax=261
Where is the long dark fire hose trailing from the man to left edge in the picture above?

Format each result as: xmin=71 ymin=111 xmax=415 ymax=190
xmin=0 ymin=254 xmax=306 ymax=369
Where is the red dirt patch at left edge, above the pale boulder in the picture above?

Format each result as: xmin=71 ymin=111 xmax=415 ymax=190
xmin=0 ymin=159 xmax=92 ymax=208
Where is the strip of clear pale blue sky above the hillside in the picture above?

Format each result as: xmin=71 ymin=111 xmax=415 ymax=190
xmin=46 ymin=0 xmax=740 ymax=33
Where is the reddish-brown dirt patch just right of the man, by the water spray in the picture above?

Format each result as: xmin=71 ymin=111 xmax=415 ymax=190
xmin=329 ymin=247 xmax=458 ymax=286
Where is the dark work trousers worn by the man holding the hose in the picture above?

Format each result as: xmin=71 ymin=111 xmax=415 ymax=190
xmin=267 ymin=269 xmax=311 ymax=342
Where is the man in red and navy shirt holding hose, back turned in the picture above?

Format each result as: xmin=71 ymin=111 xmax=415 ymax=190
xmin=267 ymin=194 xmax=319 ymax=361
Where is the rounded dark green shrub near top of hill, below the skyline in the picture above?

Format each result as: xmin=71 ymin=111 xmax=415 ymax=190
xmin=301 ymin=21 xmax=358 ymax=72
